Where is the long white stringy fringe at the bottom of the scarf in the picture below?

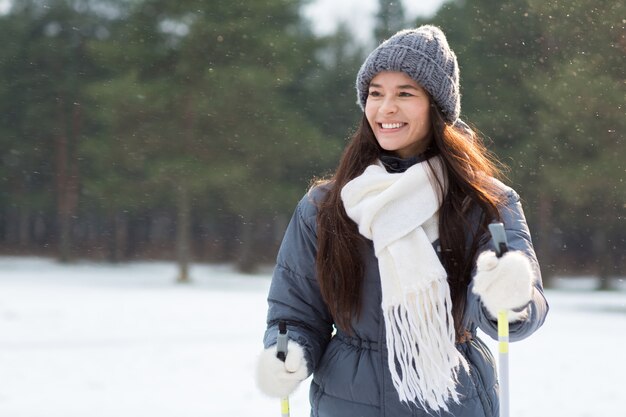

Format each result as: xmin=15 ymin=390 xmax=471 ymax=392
xmin=383 ymin=281 xmax=468 ymax=411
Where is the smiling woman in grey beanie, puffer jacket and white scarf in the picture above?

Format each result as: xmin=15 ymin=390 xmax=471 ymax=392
xmin=257 ymin=26 xmax=548 ymax=417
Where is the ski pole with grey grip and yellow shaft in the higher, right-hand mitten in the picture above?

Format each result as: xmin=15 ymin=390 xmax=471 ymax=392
xmin=489 ymin=223 xmax=509 ymax=417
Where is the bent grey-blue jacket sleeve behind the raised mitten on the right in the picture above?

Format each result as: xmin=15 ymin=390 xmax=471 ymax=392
xmin=465 ymin=187 xmax=548 ymax=342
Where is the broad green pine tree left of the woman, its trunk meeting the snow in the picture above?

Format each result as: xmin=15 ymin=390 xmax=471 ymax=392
xmin=86 ymin=0 xmax=336 ymax=281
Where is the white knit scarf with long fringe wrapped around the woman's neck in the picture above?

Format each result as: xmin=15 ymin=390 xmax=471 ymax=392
xmin=341 ymin=157 xmax=467 ymax=411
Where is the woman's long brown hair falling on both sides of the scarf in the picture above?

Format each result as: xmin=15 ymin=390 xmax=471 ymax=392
xmin=316 ymin=105 xmax=502 ymax=336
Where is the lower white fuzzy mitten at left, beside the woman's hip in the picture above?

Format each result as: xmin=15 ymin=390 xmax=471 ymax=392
xmin=256 ymin=340 xmax=308 ymax=398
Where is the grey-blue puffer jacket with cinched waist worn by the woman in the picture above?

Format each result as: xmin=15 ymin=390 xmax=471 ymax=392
xmin=264 ymin=177 xmax=548 ymax=417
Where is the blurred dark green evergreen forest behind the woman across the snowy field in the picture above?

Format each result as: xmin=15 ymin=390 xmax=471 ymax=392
xmin=0 ymin=0 xmax=626 ymax=282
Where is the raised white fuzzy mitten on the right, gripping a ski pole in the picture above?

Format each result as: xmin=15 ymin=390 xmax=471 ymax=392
xmin=473 ymin=251 xmax=534 ymax=321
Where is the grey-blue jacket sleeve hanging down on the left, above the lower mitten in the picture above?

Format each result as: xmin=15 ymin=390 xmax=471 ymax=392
xmin=263 ymin=191 xmax=333 ymax=374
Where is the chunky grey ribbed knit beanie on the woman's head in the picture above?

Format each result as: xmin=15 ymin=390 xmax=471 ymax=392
xmin=356 ymin=25 xmax=461 ymax=124
